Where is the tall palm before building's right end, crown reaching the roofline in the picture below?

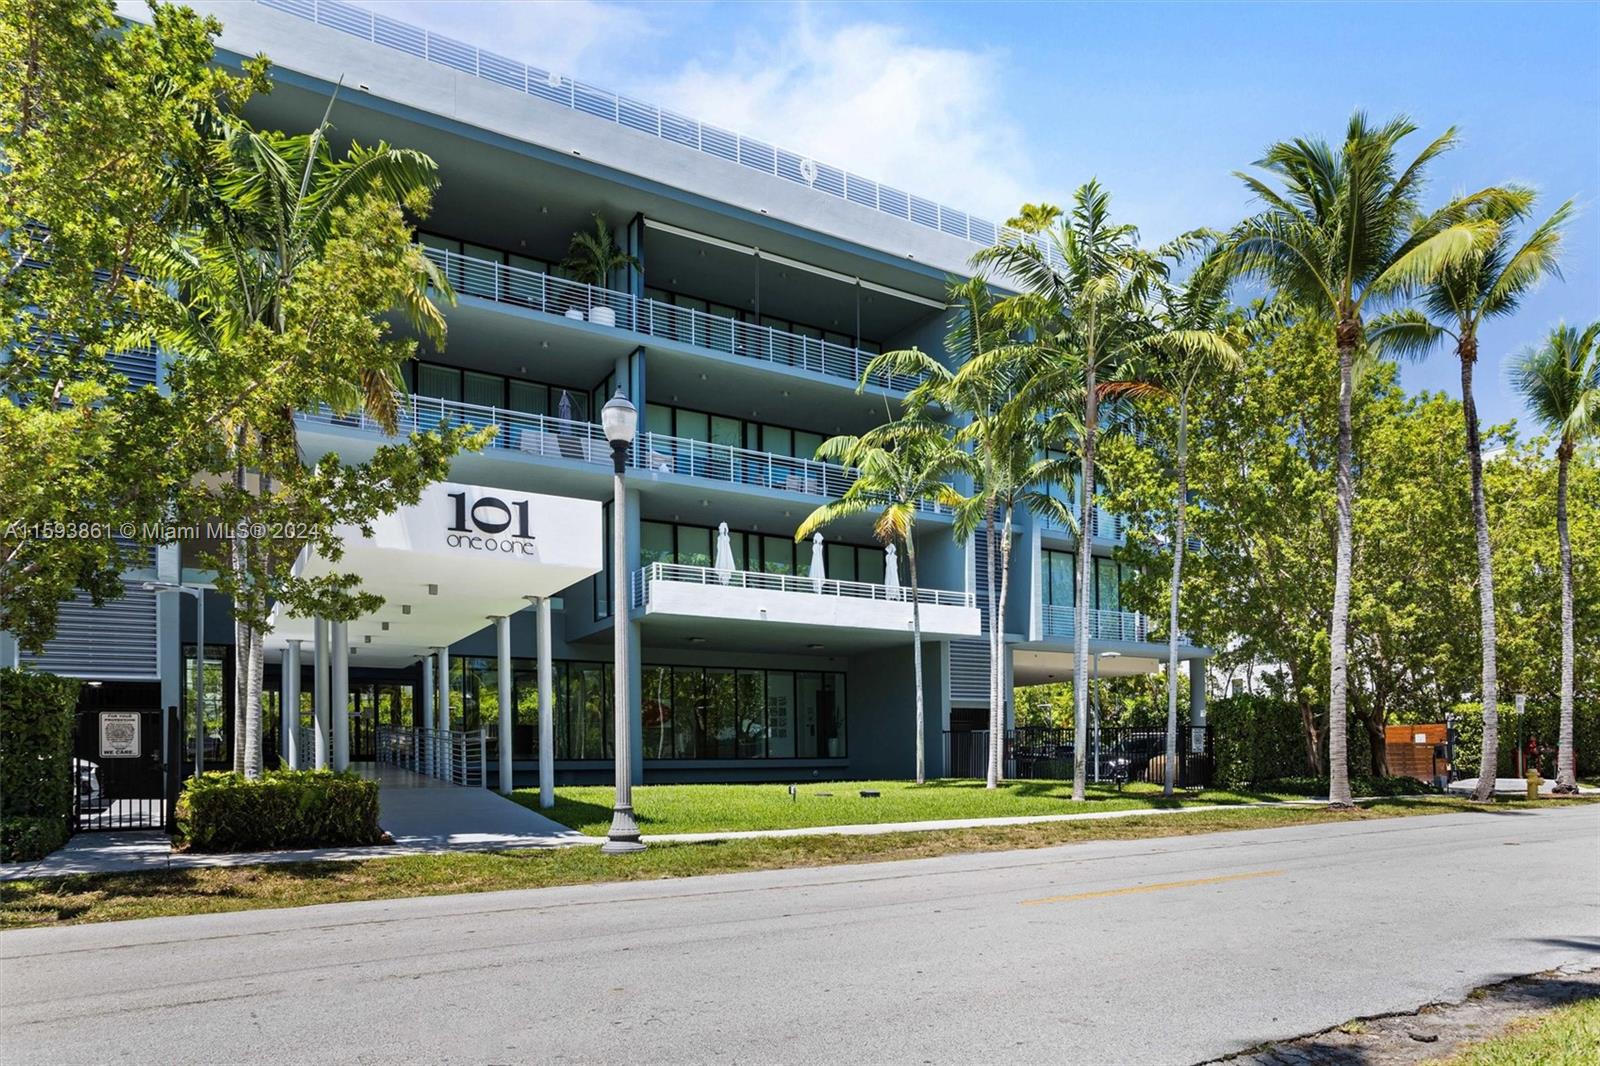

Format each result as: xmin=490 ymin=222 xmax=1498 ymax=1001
xmin=973 ymin=181 xmax=1155 ymax=799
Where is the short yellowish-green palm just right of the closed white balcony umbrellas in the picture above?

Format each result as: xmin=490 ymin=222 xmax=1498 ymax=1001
xmin=795 ymin=418 xmax=966 ymax=784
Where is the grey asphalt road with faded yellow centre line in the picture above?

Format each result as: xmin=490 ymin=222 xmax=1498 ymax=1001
xmin=0 ymin=807 xmax=1600 ymax=1066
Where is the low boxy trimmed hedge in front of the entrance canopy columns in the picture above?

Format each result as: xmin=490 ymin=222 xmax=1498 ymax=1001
xmin=173 ymin=770 xmax=387 ymax=852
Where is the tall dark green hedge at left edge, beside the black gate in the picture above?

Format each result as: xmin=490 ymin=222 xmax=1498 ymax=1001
xmin=0 ymin=669 xmax=78 ymax=863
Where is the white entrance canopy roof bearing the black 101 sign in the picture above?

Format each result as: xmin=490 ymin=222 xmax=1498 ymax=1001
xmin=266 ymin=482 xmax=602 ymax=666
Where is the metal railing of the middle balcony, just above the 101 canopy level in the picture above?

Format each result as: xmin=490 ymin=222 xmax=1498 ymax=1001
xmin=299 ymin=395 xmax=950 ymax=515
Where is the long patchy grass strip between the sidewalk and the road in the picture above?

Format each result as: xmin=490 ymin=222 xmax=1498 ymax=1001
xmin=0 ymin=797 xmax=1586 ymax=928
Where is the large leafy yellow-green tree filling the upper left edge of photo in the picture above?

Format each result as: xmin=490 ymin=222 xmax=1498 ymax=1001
xmin=0 ymin=0 xmax=266 ymax=650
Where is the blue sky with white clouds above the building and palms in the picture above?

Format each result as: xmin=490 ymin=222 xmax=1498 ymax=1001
xmin=371 ymin=0 xmax=1600 ymax=423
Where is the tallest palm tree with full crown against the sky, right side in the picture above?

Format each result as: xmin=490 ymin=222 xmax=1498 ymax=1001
xmin=1230 ymin=112 xmax=1498 ymax=808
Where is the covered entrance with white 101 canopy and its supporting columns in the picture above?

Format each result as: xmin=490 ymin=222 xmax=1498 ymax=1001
xmin=267 ymin=482 xmax=602 ymax=802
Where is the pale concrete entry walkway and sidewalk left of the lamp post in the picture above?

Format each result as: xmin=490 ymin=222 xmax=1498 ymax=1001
xmin=0 ymin=763 xmax=605 ymax=882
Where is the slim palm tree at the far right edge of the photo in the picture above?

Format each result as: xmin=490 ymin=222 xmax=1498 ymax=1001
xmin=1510 ymin=322 xmax=1600 ymax=792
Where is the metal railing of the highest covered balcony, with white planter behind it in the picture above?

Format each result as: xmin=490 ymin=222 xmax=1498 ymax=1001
xmin=426 ymin=248 xmax=920 ymax=392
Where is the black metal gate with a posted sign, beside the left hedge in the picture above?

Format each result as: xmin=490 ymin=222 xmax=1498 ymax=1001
xmin=72 ymin=707 xmax=182 ymax=832
